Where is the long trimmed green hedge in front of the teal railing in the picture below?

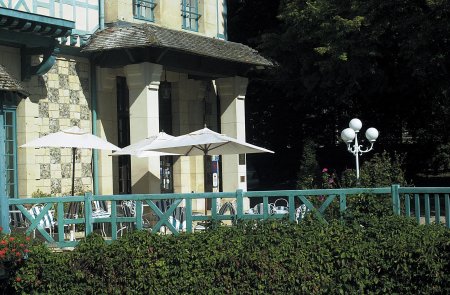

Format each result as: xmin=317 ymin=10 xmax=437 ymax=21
xmin=3 ymin=216 xmax=450 ymax=294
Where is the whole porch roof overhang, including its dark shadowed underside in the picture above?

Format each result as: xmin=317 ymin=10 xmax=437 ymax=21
xmin=82 ymin=23 xmax=273 ymax=76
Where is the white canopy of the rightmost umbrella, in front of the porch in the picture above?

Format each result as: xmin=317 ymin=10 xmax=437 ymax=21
xmin=147 ymin=127 xmax=273 ymax=156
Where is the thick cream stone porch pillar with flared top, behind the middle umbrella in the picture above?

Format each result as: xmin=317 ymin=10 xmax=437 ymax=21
xmin=124 ymin=63 xmax=162 ymax=193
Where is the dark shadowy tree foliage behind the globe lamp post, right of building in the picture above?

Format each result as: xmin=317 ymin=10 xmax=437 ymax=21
xmin=230 ymin=0 xmax=450 ymax=187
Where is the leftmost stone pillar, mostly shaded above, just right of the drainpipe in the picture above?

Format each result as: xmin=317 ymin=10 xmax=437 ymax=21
xmin=97 ymin=68 xmax=118 ymax=195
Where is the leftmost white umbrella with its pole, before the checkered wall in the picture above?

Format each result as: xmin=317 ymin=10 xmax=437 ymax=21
xmin=20 ymin=126 xmax=120 ymax=195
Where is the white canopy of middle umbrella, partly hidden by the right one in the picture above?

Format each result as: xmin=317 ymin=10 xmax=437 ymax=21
xmin=111 ymin=132 xmax=178 ymax=158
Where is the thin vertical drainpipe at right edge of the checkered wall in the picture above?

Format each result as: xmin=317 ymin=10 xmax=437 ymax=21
xmin=89 ymin=58 xmax=98 ymax=195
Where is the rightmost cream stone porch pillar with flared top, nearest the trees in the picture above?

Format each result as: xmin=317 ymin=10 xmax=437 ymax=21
xmin=216 ymin=76 xmax=248 ymax=195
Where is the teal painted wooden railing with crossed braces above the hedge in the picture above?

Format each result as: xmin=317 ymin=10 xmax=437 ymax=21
xmin=3 ymin=185 xmax=450 ymax=248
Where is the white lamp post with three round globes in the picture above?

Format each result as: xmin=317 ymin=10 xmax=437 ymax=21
xmin=341 ymin=118 xmax=378 ymax=181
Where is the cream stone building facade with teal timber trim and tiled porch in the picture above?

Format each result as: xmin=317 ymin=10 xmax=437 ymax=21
xmin=0 ymin=0 xmax=271 ymax=213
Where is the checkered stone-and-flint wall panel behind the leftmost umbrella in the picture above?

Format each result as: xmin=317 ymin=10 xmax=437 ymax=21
xmin=36 ymin=58 xmax=92 ymax=195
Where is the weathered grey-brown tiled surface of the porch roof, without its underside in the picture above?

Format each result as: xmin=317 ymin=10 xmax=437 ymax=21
xmin=82 ymin=24 xmax=273 ymax=66
